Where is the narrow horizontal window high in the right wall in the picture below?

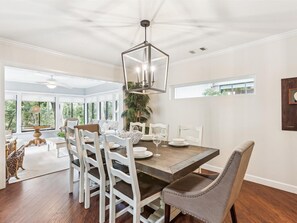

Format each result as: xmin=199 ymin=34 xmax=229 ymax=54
xmin=172 ymin=78 xmax=255 ymax=99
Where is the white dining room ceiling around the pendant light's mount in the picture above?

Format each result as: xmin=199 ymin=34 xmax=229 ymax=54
xmin=0 ymin=0 xmax=297 ymax=65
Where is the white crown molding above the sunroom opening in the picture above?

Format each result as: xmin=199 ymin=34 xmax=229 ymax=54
xmin=0 ymin=37 xmax=121 ymax=68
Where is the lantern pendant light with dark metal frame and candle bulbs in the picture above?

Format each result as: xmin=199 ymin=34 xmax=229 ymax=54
xmin=122 ymin=20 xmax=169 ymax=94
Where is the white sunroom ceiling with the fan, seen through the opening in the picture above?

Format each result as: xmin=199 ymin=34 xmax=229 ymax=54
xmin=5 ymin=67 xmax=111 ymax=89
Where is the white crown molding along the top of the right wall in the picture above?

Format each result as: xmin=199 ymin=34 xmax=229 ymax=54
xmin=171 ymin=29 xmax=297 ymax=65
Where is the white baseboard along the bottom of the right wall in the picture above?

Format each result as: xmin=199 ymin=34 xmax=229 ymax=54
xmin=202 ymin=164 xmax=297 ymax=194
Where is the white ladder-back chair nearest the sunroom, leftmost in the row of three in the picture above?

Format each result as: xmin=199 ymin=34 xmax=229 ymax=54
xmin=65 ymin=127 xmax=84 ymax=203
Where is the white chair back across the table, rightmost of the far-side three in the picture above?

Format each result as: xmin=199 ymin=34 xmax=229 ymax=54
xmin=178 ymin=125 xmax=203 ymax=146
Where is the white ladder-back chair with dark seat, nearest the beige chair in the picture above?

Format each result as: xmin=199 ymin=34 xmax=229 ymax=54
xmin=104 ymin=135 xmax=168 ymax=223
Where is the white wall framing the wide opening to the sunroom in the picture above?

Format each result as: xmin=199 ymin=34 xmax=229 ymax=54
xmin=0 ymin=40 xmax=122 ymax=189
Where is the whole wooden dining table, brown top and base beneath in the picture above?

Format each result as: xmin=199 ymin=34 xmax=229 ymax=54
xmin=128 ymin=141 xmax=220 ymax=220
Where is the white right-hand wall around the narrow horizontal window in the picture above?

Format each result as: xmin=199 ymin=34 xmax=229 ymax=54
xmin=151 ymin=33 xmax=297 ymax=193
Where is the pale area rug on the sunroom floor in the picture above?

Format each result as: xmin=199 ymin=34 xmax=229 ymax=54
xmin=9 ymin=145 xmax=69 ymax=183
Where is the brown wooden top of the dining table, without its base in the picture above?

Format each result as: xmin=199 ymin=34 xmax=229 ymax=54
xmin=117 ymin=141 xmax=220 ymax=183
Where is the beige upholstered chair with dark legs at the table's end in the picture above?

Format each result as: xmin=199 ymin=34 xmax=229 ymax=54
xmin=163 ymin=141 xmax=254 ymax=223
